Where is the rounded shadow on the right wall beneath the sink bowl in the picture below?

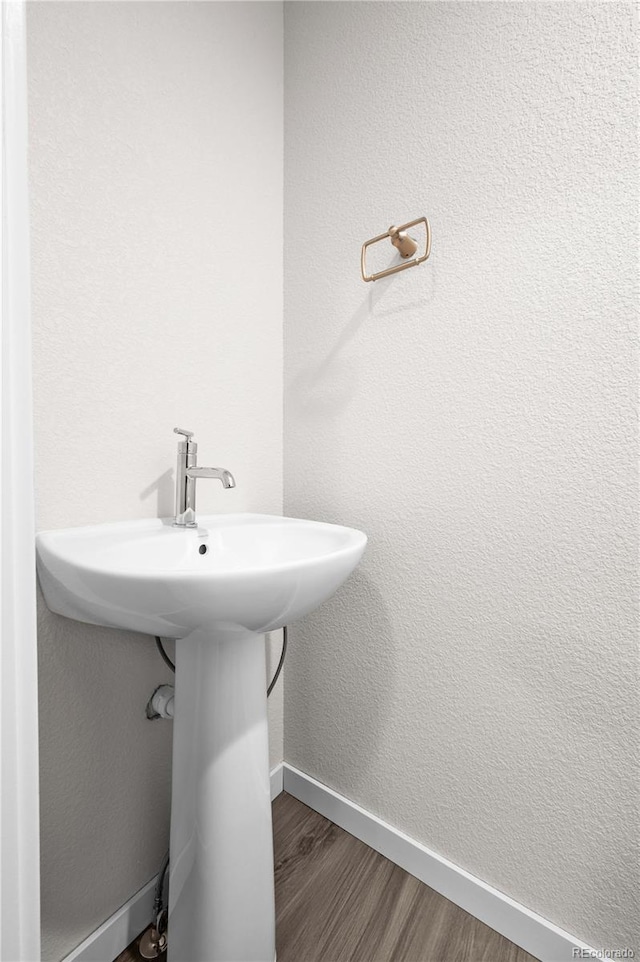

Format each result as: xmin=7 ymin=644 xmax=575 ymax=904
xmin=285 ymin=568 xmax=396 ymax=792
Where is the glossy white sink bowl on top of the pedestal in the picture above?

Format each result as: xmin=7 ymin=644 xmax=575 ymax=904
xmin=37 ymin=514 xmax=367 ymax=638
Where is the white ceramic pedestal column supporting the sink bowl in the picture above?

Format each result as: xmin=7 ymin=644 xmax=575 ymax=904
xmin=168 ymin=631 xmax=275 ymax=962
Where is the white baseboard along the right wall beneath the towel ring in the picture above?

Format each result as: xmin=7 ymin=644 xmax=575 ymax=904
xmin=283 ymin=763 xmax=595 ymax=962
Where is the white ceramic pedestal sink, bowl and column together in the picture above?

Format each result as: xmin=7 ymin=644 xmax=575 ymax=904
xmin=37 ymin=514 xmax=367 ymax=962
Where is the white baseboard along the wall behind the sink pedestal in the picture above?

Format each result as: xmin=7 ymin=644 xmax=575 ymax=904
xmin=63 ymin=763 xmax=283 ymax=962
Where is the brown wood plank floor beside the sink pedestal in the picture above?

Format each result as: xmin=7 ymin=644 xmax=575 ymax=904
xmin=115 ymin=793 xmax=536 ymax=962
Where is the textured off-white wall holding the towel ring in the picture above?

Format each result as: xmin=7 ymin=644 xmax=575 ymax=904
xmin=285 ymin=2 xmax=640 ymax=952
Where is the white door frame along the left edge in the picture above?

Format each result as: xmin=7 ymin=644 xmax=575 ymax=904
xmin=0 ymin=0 xmax=40 ymax=962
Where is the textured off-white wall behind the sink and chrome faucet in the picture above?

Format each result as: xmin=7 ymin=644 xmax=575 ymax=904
xmin=28 ymin=2 xmax=282 ymax=960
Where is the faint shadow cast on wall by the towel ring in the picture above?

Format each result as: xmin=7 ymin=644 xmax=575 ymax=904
xmin=288 ymin=270 xmax=435 ymax=420
